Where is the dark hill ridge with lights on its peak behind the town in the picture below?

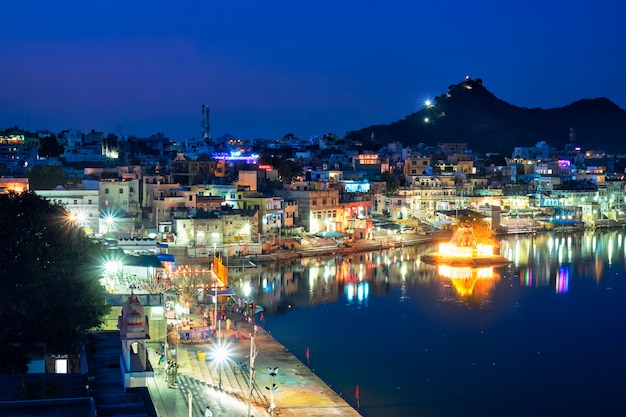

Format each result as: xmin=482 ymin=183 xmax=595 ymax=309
xmin=346 ymin=78 xmax=626 ymax=156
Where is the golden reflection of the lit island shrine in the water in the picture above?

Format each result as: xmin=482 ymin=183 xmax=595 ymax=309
xmin=437 ymin=265 xmax=499 ymax=304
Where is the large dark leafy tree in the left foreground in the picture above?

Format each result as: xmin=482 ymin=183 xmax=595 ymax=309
xmin=0 ymin=191 xmax=110 ymax=373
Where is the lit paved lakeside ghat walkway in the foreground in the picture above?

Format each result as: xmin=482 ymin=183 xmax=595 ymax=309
xmin=147 ymin=316 xmax=360 ymax=417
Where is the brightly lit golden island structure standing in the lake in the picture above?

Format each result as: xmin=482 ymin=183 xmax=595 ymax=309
xmin=421 ymin=224 xmax=511 ymax=267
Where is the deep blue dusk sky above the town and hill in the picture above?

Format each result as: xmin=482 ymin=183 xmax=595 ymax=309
xmin=0 ymin=0 xmax=626 ymax=139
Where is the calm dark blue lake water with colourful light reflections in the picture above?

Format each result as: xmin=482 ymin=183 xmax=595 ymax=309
xmin=246 ymin=230 xmax=626 ymax=417
